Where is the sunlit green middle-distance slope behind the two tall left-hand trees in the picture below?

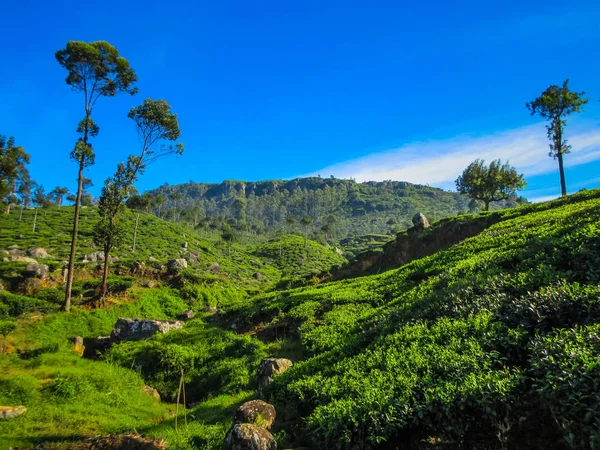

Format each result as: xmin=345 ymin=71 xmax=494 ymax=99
xmin=0 ymin=207 xmax=280 ymax=290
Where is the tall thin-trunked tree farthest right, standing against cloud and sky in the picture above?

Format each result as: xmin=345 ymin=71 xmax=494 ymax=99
xmin=525 ymin=79 xmax=588 ymax=196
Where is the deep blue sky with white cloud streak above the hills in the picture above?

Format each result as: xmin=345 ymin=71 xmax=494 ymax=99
xmin=0 ymin=0 xmax=600 ymax=199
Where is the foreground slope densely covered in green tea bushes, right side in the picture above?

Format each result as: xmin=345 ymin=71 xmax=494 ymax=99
xmin=231 ymin=190 xmax=600 ymax=448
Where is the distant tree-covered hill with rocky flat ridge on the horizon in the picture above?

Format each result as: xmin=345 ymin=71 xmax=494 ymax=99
xmin=150 ymin=177 xmax=524 ymax=239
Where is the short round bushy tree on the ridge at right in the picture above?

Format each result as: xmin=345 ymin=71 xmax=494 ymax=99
xmin=456 ymin=159 xmax=527 ymax=211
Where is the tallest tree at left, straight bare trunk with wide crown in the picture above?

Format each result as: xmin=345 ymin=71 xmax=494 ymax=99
xmin=55 ymin=41 xmax=137 ymax=311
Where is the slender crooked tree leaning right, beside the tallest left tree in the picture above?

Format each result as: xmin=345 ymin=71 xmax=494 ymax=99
xmin=94 ymin=99 xmax=183 ymax=296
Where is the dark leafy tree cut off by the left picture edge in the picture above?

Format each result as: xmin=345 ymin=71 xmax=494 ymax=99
xmin=0 ymin=134 xmax=29 ymax=213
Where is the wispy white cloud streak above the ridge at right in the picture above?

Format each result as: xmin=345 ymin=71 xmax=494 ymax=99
xmin=313 ymin=123 xmax=600 ymax=188
